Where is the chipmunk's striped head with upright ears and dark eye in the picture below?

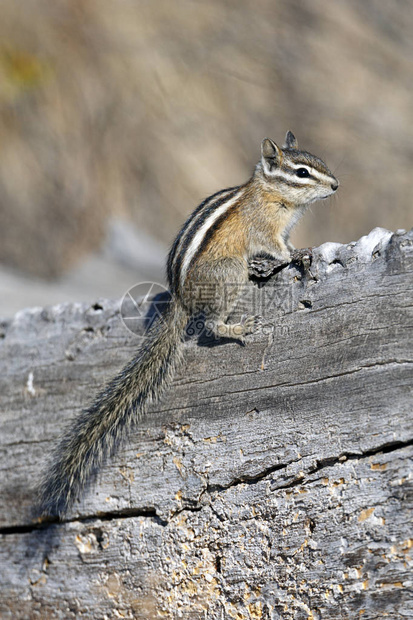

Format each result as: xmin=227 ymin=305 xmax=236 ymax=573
xmin=256 ymin=131 xmax=339 ymax=205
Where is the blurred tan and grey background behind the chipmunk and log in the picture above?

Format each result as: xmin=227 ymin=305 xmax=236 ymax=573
xmin=0 ymin=0 xmax=413 ymax=317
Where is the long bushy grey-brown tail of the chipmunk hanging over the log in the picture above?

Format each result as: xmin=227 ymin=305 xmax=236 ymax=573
xmin=40 ymin=301 xmax=187 ymax=517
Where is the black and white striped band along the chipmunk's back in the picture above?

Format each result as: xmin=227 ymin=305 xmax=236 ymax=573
xmin=167 ymin=186 xmax=244 ymax=290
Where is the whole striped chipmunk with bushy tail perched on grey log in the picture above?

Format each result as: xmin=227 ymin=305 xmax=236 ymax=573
xmin=40 ymin=131 xmax=339 ymax=517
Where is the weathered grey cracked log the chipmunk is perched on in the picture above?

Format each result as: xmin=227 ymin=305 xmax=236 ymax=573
xmin=0 ymin=229 xmax=413 ymax=620
